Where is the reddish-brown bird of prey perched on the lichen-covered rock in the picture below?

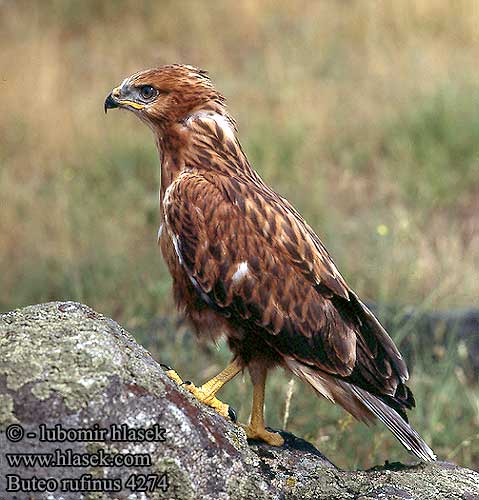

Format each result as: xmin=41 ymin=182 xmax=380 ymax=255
xmin=105 ymin=64 xmax=435 ymax=461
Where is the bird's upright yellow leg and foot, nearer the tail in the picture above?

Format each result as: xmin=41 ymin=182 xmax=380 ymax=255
xmin=244 ymin=366 xmax=284 ymax=446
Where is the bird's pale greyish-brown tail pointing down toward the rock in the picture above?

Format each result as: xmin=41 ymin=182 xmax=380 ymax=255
xmin=285 ymin=357 xmax=436 ymax=462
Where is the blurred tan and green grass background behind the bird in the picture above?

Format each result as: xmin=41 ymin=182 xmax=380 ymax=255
xmin=0 ymin=0 xmax=479 ymax=468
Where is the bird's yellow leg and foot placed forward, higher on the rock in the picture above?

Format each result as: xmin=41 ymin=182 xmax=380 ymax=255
xmin=166 ymin=359 xmax=243 ymax=421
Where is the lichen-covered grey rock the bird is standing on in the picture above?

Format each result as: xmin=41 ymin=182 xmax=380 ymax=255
xmin=0 ymin=302 xmax=479 ymax=500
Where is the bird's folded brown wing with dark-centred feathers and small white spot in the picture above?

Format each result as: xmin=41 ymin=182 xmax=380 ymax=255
xmin=164 ymin=173 xmax=407 ymax=386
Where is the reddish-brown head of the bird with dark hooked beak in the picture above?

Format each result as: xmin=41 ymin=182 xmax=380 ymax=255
xmin=105 ymin=64 xmax=224 ymax=130
